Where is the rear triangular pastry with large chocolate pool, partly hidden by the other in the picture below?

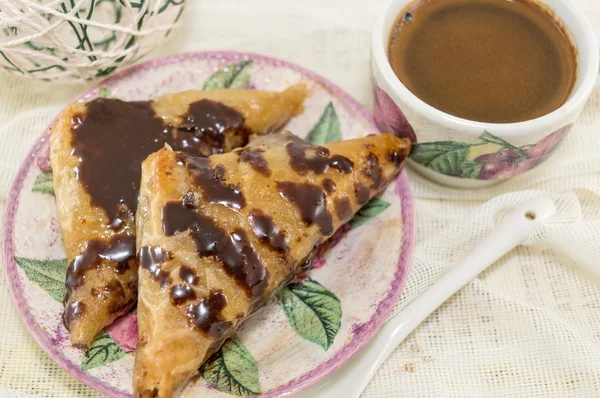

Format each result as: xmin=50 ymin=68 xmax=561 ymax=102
xmin=51 ymin=84 xmax=306 ymax=346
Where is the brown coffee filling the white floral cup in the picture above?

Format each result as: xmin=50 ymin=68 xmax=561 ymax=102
xmin=388 ymin=0 xmax=577 ymax=123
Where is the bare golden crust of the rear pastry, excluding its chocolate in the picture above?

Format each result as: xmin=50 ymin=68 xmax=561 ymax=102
xmin=50 ymin=84 xmax=306 ymax=346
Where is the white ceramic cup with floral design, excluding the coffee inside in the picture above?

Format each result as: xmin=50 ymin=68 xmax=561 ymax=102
xmin=371 ymin=0 xmax=600 ymax=188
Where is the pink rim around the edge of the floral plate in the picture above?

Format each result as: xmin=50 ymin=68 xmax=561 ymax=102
xmin=3 ymin=51 xmax=415 ymax=398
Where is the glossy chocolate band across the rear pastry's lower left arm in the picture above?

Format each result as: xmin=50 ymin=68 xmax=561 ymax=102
xmin=65 ymin=235 xmax=135 ymax=300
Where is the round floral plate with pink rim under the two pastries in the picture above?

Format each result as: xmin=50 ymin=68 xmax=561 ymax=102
xmin=4 ymin=52 xmax=414 ymax=397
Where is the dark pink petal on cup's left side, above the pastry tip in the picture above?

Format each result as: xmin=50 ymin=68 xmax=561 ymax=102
xmin=373 ymin=87 xmax=417 ymax=142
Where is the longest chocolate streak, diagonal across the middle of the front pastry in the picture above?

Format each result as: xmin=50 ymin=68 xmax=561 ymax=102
xmin=162 ymin=197 xmax=268 ymax=298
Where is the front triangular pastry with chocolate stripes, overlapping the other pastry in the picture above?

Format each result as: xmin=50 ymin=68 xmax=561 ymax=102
xmin=134 ymin=133 xmax=410 ymax=398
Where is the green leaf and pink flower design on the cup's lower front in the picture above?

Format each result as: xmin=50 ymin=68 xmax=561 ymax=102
xmin=410 ymin=125 xmax=572 ymax=181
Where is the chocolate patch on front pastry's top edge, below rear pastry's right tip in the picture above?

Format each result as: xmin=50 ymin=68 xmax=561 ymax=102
xmin=285 ymin=142 xmax=354 ymax=175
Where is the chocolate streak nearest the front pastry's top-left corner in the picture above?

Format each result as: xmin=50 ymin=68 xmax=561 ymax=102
xmin=178 ymin=154 xmax=246 ymax=210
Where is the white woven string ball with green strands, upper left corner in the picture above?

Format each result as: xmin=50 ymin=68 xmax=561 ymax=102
xmin=0 ymin=0 xmax=185 ymax=81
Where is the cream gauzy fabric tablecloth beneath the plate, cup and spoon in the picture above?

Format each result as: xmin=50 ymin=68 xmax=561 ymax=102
xmin=0 ymin=0 xmax=600 ymax=398
